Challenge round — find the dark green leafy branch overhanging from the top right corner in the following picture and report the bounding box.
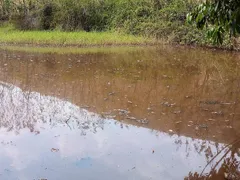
[187,0,240,44]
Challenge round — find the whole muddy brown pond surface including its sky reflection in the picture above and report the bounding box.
[0,47,240,180]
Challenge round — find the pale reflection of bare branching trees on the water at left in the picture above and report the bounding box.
[0,82,104,135]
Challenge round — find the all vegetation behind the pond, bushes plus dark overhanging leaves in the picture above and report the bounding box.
[0,0,240,47]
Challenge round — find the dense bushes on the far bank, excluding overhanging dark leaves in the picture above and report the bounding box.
[0,0,205,44]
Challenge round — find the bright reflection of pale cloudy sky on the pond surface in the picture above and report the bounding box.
[0,84,234,180]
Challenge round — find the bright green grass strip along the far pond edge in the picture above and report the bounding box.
[0,27,155,46]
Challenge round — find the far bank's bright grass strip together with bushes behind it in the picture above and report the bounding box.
[0,0,206,45]
